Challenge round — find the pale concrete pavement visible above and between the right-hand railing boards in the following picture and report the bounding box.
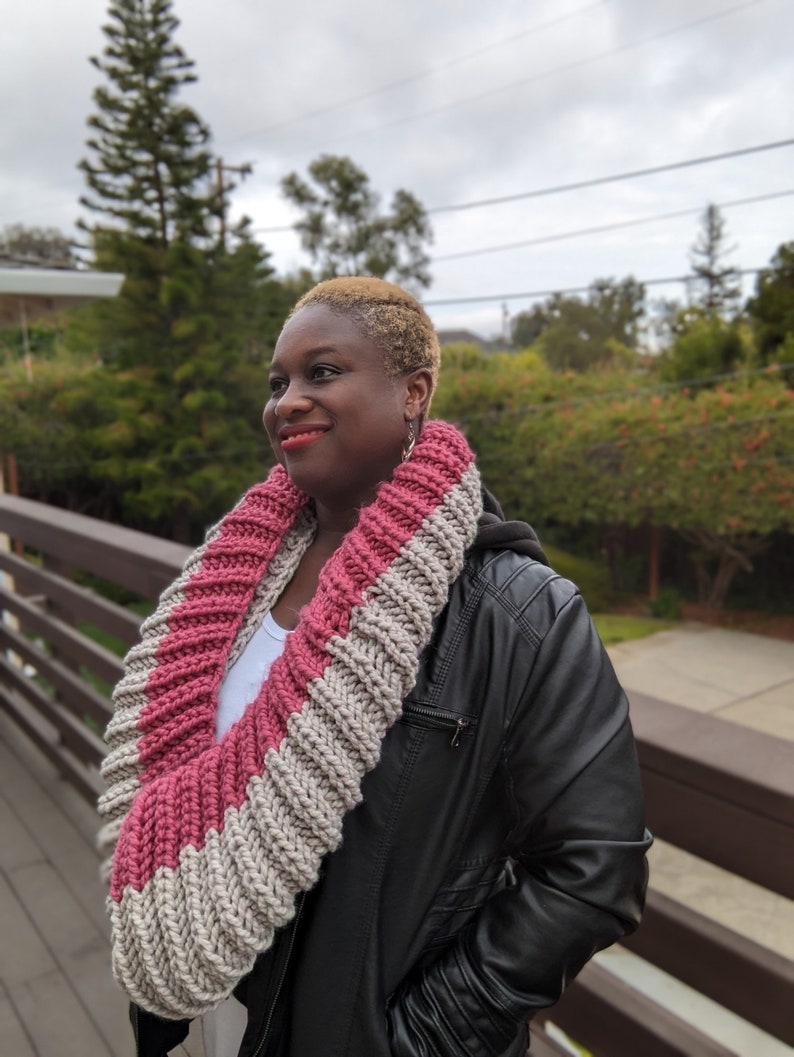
[597,624,794,1057]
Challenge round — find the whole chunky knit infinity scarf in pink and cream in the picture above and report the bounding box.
[99,423,481,1019]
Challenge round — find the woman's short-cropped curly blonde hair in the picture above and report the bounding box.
[287,276,441,386]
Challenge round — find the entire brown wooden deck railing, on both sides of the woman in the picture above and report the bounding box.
[0,496,794,1057]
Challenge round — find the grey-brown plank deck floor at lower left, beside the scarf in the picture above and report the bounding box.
[0,715,203,1057]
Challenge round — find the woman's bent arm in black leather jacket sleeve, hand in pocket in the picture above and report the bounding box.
[389,581,650,1057]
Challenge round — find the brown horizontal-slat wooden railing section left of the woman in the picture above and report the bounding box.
[0,495,188,802]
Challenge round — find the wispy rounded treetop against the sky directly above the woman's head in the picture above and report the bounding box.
[281,154,432,288]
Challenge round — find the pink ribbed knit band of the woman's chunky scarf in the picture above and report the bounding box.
[111,423,473,902]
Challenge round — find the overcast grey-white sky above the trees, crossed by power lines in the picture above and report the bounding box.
[0,0,794,336]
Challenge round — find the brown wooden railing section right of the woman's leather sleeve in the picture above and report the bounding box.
[551,693,794,1057]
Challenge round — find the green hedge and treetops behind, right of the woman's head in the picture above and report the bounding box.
[441,217,794,607]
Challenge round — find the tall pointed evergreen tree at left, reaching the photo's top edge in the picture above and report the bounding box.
[75,0,283,540]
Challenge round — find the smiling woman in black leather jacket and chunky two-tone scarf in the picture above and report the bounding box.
[100,278,649,1057]
